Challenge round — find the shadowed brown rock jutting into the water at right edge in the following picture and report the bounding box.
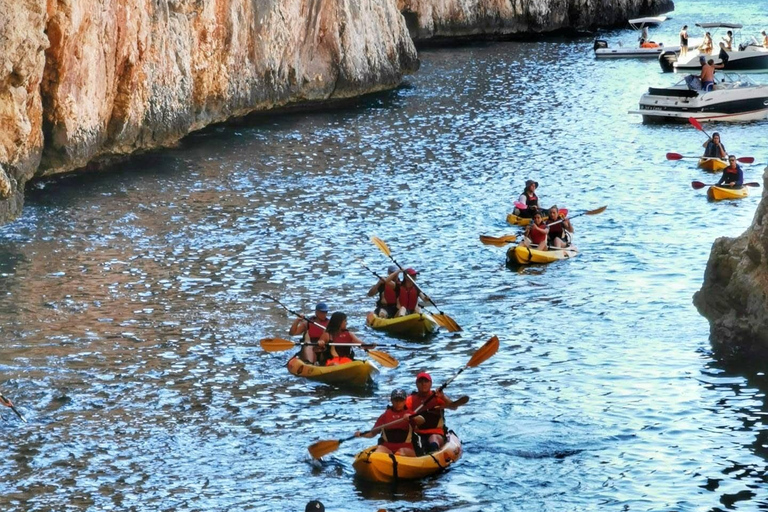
[693,167,768,359]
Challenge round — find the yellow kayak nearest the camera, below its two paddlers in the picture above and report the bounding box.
[352,432,462,483]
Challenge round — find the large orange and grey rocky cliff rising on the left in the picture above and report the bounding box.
[0,0,418,221]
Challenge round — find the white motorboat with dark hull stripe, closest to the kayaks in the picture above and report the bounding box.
[629,74,768,123]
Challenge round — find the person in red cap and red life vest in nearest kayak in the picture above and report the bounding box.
[405,372,453,455]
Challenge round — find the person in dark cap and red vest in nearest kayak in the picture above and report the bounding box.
[355,389,424,457]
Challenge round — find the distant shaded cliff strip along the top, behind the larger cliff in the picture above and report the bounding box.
[397,0,674,42]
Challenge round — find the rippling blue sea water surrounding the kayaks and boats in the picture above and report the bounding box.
[0,2,768,511]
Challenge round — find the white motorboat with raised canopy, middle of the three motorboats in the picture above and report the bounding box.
[659,23,768,73]
